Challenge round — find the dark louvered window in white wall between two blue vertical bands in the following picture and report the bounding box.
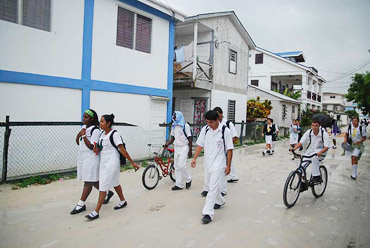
[116,7,152,53]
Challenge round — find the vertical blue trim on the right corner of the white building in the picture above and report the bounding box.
[166,19,175,139]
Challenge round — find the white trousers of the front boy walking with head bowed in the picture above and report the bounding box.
[202,169,225,219]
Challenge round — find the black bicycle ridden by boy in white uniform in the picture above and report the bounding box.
[283,151,328,208]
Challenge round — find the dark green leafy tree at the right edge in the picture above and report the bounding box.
[345,71,370,115]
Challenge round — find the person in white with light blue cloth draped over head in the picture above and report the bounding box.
[165,111,193,190]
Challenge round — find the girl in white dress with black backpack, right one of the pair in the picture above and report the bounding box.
[85,114,139,220]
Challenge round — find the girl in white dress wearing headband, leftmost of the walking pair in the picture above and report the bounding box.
[71,109,100,214]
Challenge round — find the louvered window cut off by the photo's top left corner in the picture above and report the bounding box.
[0,0,51,31]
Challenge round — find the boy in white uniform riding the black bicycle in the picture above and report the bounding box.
[292,118,330,182]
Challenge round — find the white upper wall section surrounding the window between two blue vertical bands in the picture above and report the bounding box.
[91,0,169,89]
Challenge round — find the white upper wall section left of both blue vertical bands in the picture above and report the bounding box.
[0,0,84,79]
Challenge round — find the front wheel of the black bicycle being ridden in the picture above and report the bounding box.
[283,171,301,208]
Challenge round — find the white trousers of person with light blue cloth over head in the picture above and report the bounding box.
[174,146,191,188]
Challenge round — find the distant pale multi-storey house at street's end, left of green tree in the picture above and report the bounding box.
[323,92,348,125]
